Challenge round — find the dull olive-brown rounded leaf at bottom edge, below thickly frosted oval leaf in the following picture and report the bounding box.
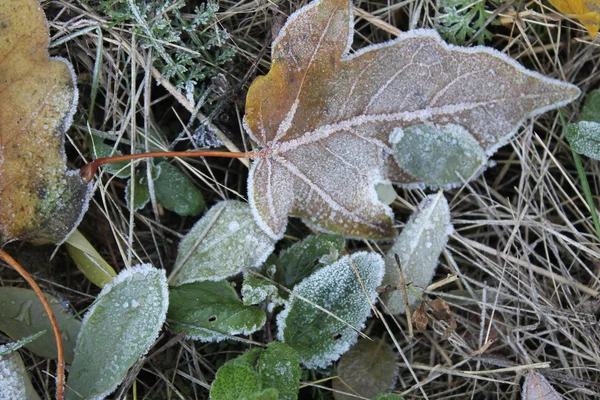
[333,339,398,400]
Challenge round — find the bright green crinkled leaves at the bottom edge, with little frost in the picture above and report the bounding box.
[210,342,301,400]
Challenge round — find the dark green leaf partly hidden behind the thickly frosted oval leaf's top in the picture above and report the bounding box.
[277,234,345,289]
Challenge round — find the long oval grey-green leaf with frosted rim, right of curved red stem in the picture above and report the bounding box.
[66,264,169,400]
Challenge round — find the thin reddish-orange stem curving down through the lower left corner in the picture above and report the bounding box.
[0,249,65,400]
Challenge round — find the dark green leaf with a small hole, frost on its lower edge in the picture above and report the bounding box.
[168,281,266,342]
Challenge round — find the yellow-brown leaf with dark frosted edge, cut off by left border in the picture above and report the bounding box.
[0,0,90,245]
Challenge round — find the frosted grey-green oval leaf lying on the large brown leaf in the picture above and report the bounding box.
[390,124,487,186]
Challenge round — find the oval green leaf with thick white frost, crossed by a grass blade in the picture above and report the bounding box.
[277,252,385,369]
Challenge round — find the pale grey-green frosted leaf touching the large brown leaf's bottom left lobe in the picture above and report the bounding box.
[169,201,274,286]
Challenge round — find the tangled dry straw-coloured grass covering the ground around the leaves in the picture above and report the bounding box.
[2,0,600,400]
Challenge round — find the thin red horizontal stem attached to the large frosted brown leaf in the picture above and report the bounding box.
[79,150,266,182]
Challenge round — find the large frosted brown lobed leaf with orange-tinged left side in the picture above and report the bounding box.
[245,0,579,239]
